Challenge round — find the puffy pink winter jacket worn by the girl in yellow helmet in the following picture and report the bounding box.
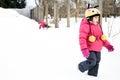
[79,18,110,52]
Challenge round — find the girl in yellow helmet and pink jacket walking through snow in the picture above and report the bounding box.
[78,8,114,76]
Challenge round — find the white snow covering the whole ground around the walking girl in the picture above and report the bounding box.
[0,8,120,80]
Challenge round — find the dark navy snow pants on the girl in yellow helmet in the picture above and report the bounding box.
[78,51,101,76]
